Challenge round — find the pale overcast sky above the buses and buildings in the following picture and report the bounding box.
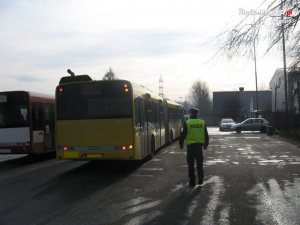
[0,0,288,100]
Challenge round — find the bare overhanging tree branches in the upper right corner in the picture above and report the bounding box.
[215,0,300,65]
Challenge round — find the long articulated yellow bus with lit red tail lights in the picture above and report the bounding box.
[56,75,183,160]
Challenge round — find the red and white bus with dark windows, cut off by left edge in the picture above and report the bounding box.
[0,91,55,154]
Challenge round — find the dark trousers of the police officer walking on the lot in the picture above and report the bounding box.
[186,144,204,183]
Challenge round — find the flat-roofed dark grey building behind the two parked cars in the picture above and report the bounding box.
[213,88,272,125]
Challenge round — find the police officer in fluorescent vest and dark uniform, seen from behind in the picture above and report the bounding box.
[179,108,209,187]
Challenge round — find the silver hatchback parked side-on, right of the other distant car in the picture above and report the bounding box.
[231,118,269,133]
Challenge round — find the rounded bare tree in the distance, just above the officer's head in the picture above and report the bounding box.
[190,80,212,116]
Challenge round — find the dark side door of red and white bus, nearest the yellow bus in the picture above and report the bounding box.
[43,104,54,151]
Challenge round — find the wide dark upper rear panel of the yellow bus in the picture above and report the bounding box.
[56,81,132,120]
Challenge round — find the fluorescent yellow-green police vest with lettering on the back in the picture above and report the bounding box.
[184,119,205,145]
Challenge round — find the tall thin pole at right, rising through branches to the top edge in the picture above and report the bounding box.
[280,0,289,131]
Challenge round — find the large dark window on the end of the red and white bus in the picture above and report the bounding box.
[0,92,29,128]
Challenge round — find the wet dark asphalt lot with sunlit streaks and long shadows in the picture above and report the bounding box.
[0,128,300,225]
